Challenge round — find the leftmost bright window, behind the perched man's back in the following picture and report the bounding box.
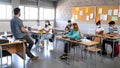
[0,4,12,20]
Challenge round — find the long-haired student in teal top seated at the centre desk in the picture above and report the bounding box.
[60,23,82,59]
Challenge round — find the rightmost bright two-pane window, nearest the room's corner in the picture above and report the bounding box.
[39,8,54,20]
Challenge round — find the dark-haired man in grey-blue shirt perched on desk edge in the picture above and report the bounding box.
[10,8,38,61]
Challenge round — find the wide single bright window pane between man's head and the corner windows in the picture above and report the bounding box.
[25,7,38,20]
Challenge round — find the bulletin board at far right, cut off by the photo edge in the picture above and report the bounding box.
[96,5,120,24]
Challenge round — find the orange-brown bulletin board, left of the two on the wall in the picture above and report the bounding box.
[71,6,96,22]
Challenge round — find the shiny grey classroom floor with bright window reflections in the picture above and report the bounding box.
[2,42,120,68]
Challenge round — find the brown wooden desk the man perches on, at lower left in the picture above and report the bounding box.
[0,41,26,68]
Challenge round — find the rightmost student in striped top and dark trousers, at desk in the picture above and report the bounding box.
[102,21,118,55]
